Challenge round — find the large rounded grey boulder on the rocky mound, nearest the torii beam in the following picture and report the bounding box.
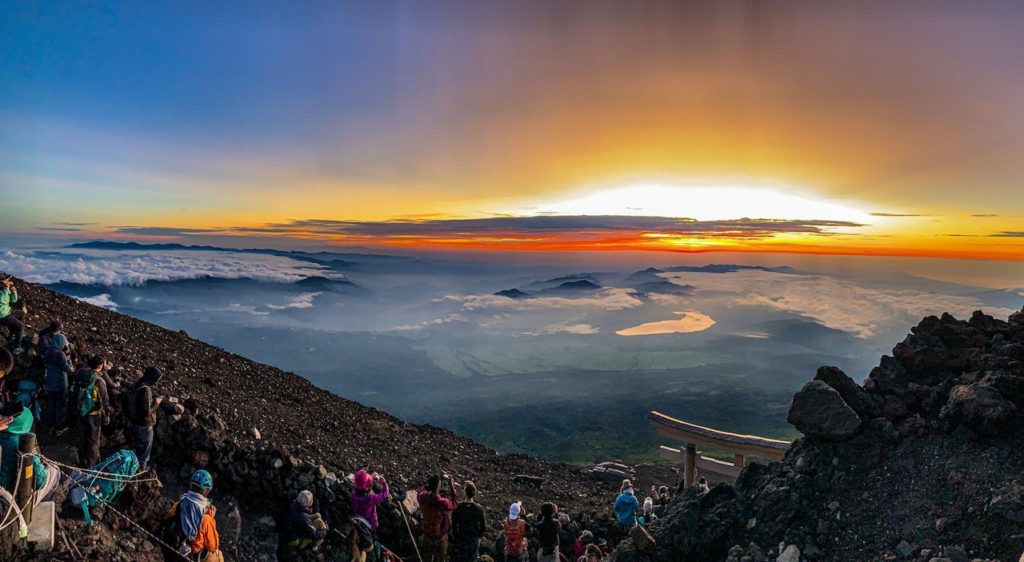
[786,380,860,441]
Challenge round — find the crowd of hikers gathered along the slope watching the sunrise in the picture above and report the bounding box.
[0,278,708,562]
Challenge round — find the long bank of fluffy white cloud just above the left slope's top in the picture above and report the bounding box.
[0,250,327,286]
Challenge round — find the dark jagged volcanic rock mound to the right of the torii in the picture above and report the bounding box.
[615,311,1024,562]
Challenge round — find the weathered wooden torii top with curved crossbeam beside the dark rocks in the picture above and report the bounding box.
[647,412,791,486]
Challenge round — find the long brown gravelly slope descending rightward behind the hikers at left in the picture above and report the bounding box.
[4,282,615,560]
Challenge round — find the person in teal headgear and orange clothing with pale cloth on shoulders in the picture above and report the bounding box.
[165,470,224,562]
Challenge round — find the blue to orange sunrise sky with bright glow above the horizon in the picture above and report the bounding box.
[0,0,1024,261]
